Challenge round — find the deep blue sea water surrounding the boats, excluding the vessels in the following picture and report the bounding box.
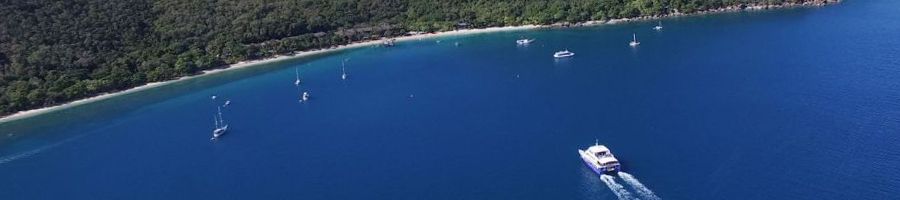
[0,0,900,199]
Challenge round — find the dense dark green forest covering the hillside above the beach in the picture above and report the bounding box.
[0,0,822,115]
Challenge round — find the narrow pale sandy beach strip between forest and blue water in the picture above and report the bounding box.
[0,0,841,123]
